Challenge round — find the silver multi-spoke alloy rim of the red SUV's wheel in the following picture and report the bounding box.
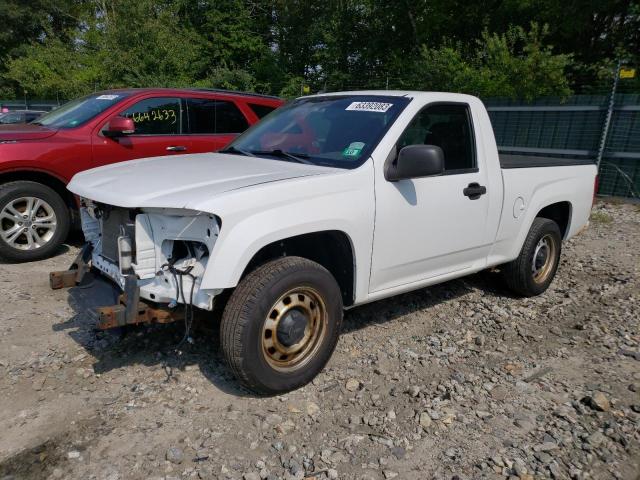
[0,197,57,251]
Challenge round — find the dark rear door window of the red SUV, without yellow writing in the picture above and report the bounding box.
[187,98,249,134]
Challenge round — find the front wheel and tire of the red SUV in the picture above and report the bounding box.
[0,181,70,262]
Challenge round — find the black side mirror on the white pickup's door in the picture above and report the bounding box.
[384,145,444,182]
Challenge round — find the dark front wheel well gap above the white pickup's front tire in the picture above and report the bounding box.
[242,230,355,306]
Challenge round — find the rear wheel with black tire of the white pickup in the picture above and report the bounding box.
[502,217,562,297]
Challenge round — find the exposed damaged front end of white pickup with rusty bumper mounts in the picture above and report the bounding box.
[50,199,221,328]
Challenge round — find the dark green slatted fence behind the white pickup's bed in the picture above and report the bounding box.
[485,94,640,198]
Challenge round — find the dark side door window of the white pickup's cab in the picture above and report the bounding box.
[398,105,476,170]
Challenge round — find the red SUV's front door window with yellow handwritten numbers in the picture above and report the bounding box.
[121,97,181,135]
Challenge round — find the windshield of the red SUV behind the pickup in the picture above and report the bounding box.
[32,93,127,128]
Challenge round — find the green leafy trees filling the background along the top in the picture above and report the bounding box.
[0,0,640,98]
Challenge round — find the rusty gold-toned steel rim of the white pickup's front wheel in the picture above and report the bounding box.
[261,287,328,372]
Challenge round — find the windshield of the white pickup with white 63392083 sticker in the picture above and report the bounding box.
[223,95,410,168]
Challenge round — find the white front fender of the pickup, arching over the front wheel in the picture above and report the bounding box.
[202,162,374,298]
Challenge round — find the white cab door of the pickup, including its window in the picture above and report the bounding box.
[370,103,491,293]
